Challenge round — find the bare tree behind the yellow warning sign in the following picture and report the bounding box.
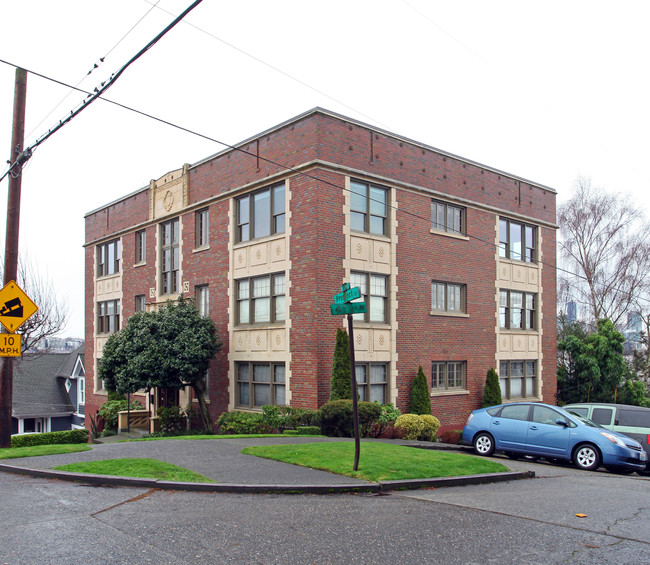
[2,257,69,355]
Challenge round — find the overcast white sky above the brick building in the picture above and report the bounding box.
[0,0,650,337]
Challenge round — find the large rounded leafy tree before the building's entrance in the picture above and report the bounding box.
[98,297,221,432]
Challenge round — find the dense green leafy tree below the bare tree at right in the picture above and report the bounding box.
[557,319,629,403]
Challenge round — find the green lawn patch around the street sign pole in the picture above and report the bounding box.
[242,442,509,482]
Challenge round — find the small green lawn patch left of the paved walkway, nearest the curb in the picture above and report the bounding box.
[54,458,215,483]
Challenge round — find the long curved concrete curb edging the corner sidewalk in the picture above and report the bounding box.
[0,464,535,494]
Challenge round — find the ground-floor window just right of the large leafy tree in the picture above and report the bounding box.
[237,363,286,408]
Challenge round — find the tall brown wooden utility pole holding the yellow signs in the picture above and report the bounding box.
[0,68,29,447]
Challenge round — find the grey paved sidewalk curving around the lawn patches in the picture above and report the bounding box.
[0,434,534,494]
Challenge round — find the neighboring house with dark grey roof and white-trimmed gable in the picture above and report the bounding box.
[11,346,85,434]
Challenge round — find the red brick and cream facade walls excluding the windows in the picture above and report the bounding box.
[85,109,556,429]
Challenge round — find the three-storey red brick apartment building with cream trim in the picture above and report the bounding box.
[85,108,556,429]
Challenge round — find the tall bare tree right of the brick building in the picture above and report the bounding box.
[558,178,650,326]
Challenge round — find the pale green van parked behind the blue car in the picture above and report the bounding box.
[563,402,650,475]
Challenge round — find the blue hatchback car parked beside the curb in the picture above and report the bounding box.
[463,402,648,473]
